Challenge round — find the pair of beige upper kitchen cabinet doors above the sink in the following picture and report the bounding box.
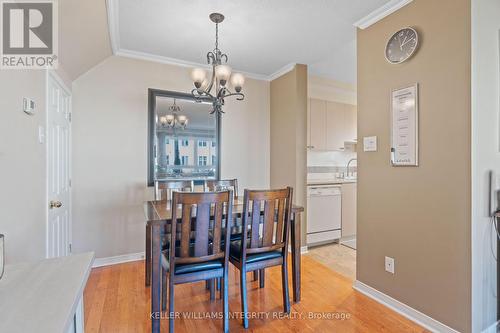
[307,98,357,151]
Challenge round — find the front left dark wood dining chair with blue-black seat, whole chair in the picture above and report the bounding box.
[162,191,233,332]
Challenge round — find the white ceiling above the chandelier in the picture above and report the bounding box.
[110,0,388,83]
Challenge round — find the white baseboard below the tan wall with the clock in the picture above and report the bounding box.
[352,280,459,333]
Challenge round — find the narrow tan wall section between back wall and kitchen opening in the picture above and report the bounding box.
[271,65,307,244]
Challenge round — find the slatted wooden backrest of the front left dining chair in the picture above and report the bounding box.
[170,191,233,266]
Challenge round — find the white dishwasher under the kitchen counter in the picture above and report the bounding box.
[307,185,342,245]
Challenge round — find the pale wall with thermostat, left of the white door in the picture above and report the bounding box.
[0,70,47,263]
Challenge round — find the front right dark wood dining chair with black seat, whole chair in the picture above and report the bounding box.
[229,187,293,328]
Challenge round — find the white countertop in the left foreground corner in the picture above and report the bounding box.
[0,253,94,333]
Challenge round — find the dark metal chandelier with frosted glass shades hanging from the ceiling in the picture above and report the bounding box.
[191,13,245,114]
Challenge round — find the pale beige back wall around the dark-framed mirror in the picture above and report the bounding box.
[73,56,270,258]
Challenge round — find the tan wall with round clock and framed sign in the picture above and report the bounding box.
[357,0,471,332]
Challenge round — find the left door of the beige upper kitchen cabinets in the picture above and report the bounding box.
[308,98,327,150]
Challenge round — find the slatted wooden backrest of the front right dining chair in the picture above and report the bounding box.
[241,187,293,260]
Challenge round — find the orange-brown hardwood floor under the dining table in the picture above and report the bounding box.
[84,256,426,332]
